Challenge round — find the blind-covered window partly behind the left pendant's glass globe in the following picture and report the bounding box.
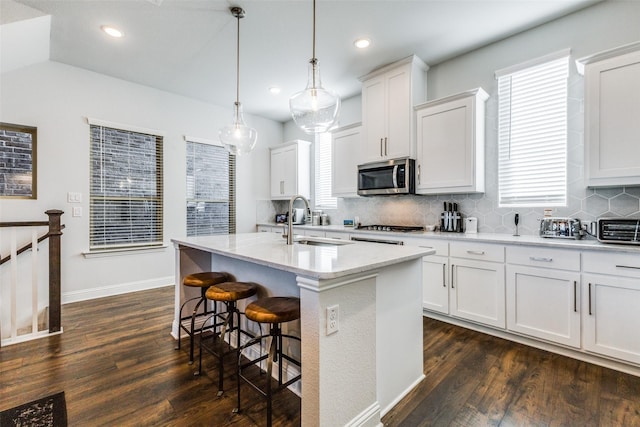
[186,137,236,236]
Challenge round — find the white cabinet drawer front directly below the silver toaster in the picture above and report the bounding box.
[507,246,580,271]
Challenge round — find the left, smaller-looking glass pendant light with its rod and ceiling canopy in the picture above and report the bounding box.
[218,7,258,155]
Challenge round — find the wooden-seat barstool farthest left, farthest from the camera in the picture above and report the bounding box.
[176,271,230,364]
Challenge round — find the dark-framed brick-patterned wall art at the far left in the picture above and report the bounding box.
[0,122,37,199]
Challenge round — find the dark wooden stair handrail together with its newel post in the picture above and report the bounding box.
[0,209,64,346]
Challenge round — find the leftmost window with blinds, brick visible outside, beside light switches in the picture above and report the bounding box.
[89,119,163,250]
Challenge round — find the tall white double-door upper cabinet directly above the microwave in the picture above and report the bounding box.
[360,55,429,163]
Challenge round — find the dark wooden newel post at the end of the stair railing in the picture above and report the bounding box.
[45,209,64,333]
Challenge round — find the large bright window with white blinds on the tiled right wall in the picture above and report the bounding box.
[496,51,569,207]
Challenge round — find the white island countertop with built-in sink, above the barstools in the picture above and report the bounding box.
[171,233,435,279]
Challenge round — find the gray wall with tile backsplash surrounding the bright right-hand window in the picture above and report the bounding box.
[282,1,640,234]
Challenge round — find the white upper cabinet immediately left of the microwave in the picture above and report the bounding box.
[331,123,362,197]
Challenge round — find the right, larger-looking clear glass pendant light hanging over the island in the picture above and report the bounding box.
[289,0,340,134]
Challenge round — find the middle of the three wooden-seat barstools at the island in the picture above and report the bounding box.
[196,282,258,396]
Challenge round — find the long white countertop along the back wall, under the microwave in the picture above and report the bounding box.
[257,223,640,255]
